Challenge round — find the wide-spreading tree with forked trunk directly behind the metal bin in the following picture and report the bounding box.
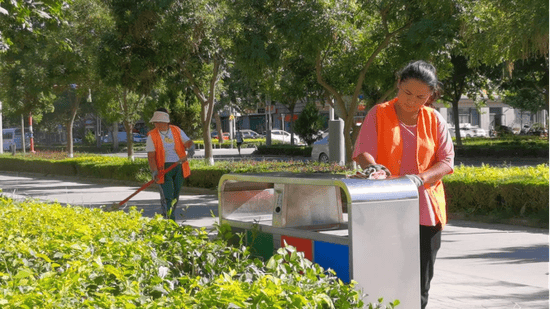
[236,0,457,162]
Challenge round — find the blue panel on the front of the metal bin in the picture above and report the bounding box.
[313,241,350,283]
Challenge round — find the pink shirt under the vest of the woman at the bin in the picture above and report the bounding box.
[352,105,455,226]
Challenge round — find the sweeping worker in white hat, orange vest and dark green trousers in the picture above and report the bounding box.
[145,108,193,220]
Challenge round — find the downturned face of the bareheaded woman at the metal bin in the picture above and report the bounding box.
[397,78,432,112]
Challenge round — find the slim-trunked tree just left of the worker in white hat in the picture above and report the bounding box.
[98,0,172,160]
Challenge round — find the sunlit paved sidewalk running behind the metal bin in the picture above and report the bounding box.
[0,172,550,309]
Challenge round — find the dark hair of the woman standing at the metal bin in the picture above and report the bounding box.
[397,60,441,102]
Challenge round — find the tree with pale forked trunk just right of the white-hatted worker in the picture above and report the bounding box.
[157,0,233,164]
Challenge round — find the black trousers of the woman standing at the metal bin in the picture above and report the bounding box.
[420,225,441,309]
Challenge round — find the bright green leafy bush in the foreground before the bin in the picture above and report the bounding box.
[0,197,380,309]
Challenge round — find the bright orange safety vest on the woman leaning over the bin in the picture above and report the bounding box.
[375,98,447,227]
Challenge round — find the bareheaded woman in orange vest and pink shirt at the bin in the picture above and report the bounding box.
[353,61,454,308]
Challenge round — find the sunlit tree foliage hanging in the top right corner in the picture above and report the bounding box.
[462,0,550,159]
